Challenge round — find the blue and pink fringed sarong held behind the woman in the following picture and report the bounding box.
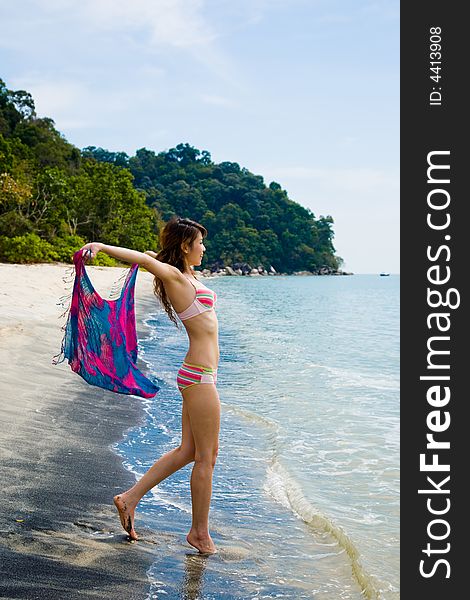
[53,250,160,398]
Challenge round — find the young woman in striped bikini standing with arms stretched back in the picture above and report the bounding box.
[82,217,220,554]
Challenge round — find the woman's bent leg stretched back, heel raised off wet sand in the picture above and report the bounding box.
[113,398,196,540]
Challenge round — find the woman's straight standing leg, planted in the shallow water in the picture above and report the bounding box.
[182,383,220,553]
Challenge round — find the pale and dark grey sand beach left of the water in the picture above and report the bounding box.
[0,263,165,599]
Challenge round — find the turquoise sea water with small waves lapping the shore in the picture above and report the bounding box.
[114,275,400,600]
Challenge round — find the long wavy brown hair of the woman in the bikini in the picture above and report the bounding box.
[153,216,207,327]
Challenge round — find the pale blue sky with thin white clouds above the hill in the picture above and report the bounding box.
[0,0,400,273]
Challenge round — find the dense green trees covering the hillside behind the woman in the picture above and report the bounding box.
[0,79,342,273]
